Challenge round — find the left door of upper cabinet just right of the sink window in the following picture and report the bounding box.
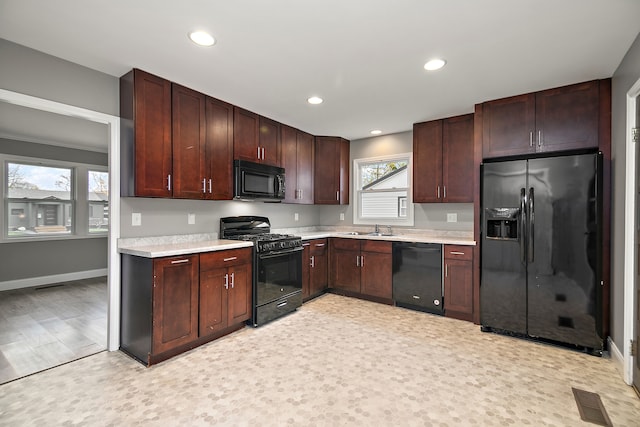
[413,120,442,203]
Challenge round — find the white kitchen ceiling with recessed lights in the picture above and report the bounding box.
[0,0,640,149]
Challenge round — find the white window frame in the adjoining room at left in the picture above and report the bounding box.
[0,153,111,243]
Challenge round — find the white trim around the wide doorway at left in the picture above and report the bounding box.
[0,89,120,351]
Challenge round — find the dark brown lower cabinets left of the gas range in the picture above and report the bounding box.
[120,248,252,365]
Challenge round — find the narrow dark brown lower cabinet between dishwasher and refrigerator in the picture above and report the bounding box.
[444,245,473,321]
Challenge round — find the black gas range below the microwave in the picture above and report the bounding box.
[220,216,303,326]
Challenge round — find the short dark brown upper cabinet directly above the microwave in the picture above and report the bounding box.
[233,107,280,166]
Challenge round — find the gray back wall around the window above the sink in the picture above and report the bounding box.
[319,131,473,231]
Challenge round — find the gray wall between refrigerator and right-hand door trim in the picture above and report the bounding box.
[611,34,640,350]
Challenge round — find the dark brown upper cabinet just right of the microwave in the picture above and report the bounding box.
[280,125,314,204]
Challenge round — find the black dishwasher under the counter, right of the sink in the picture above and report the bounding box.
[393,242,444,315]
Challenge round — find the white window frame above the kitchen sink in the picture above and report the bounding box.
[352,153,414,227]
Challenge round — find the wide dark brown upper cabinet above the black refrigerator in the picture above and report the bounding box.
[482,80,600,158]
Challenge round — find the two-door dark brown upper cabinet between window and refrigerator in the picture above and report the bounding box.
[413,114,474,203]
